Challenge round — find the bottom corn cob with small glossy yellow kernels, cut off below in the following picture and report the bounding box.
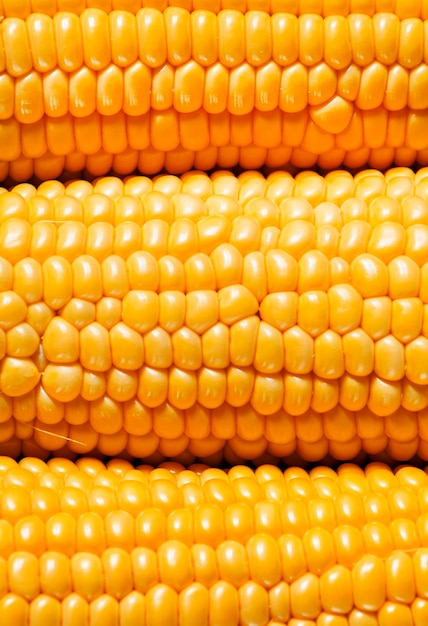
[0,457,428,626]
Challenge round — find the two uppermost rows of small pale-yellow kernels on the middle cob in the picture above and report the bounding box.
[5,167,428,210]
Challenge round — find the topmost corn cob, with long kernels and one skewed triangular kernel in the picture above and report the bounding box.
[0,7,428,181]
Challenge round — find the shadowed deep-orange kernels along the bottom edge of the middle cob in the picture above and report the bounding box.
[0,398,428,465]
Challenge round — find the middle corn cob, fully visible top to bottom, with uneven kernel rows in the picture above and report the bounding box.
[0,168,428,463]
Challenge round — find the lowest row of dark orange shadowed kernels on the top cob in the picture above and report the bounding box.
[0,141,428,180]
